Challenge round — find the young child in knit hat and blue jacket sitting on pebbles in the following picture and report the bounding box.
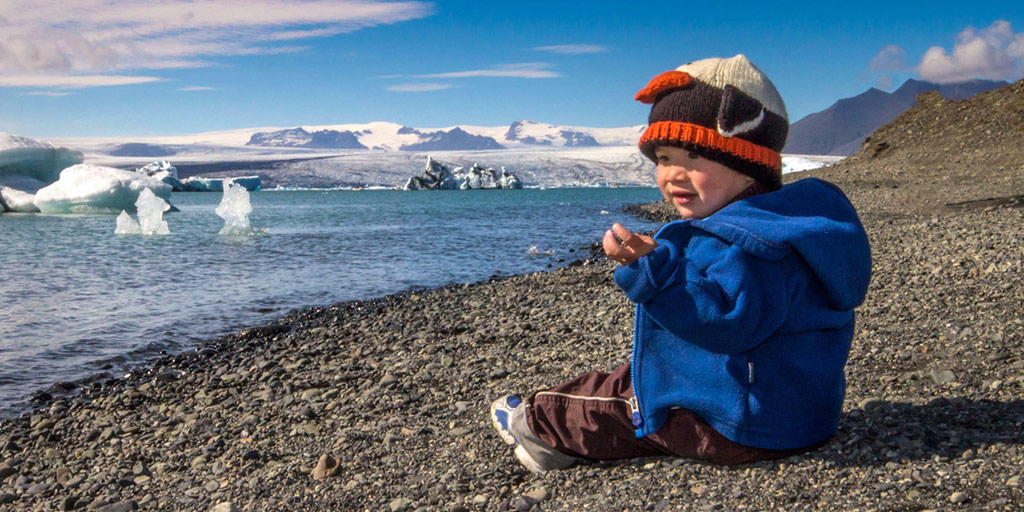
[490,55,871,472]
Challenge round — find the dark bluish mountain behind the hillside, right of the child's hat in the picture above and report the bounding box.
[782,80,1008,157]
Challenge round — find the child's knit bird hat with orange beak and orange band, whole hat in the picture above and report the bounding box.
[636,55,790,190]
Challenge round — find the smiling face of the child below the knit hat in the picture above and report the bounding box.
[654,145,754,219]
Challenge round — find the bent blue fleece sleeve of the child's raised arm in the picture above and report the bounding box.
[615,237,800,353]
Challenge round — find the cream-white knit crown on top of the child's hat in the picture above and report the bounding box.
[676,54,790,121]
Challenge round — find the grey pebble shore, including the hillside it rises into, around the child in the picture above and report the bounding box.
[0,81,1024,512]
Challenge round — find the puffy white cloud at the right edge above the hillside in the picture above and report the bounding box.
[918,19,1024,83]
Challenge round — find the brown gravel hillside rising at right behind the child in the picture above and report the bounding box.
[787,80,1024,213]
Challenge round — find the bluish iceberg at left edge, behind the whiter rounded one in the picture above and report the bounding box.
[0,132,82,183]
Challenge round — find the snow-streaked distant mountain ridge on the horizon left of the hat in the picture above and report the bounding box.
[245,121,643,152]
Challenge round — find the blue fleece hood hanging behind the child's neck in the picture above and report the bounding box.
[690,178,871,309]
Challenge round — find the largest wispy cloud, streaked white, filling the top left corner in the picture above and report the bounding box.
[0,0,433,86]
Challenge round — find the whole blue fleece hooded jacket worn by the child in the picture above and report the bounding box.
[615,178,871,450]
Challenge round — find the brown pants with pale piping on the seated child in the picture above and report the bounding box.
[526,364,811,465]
